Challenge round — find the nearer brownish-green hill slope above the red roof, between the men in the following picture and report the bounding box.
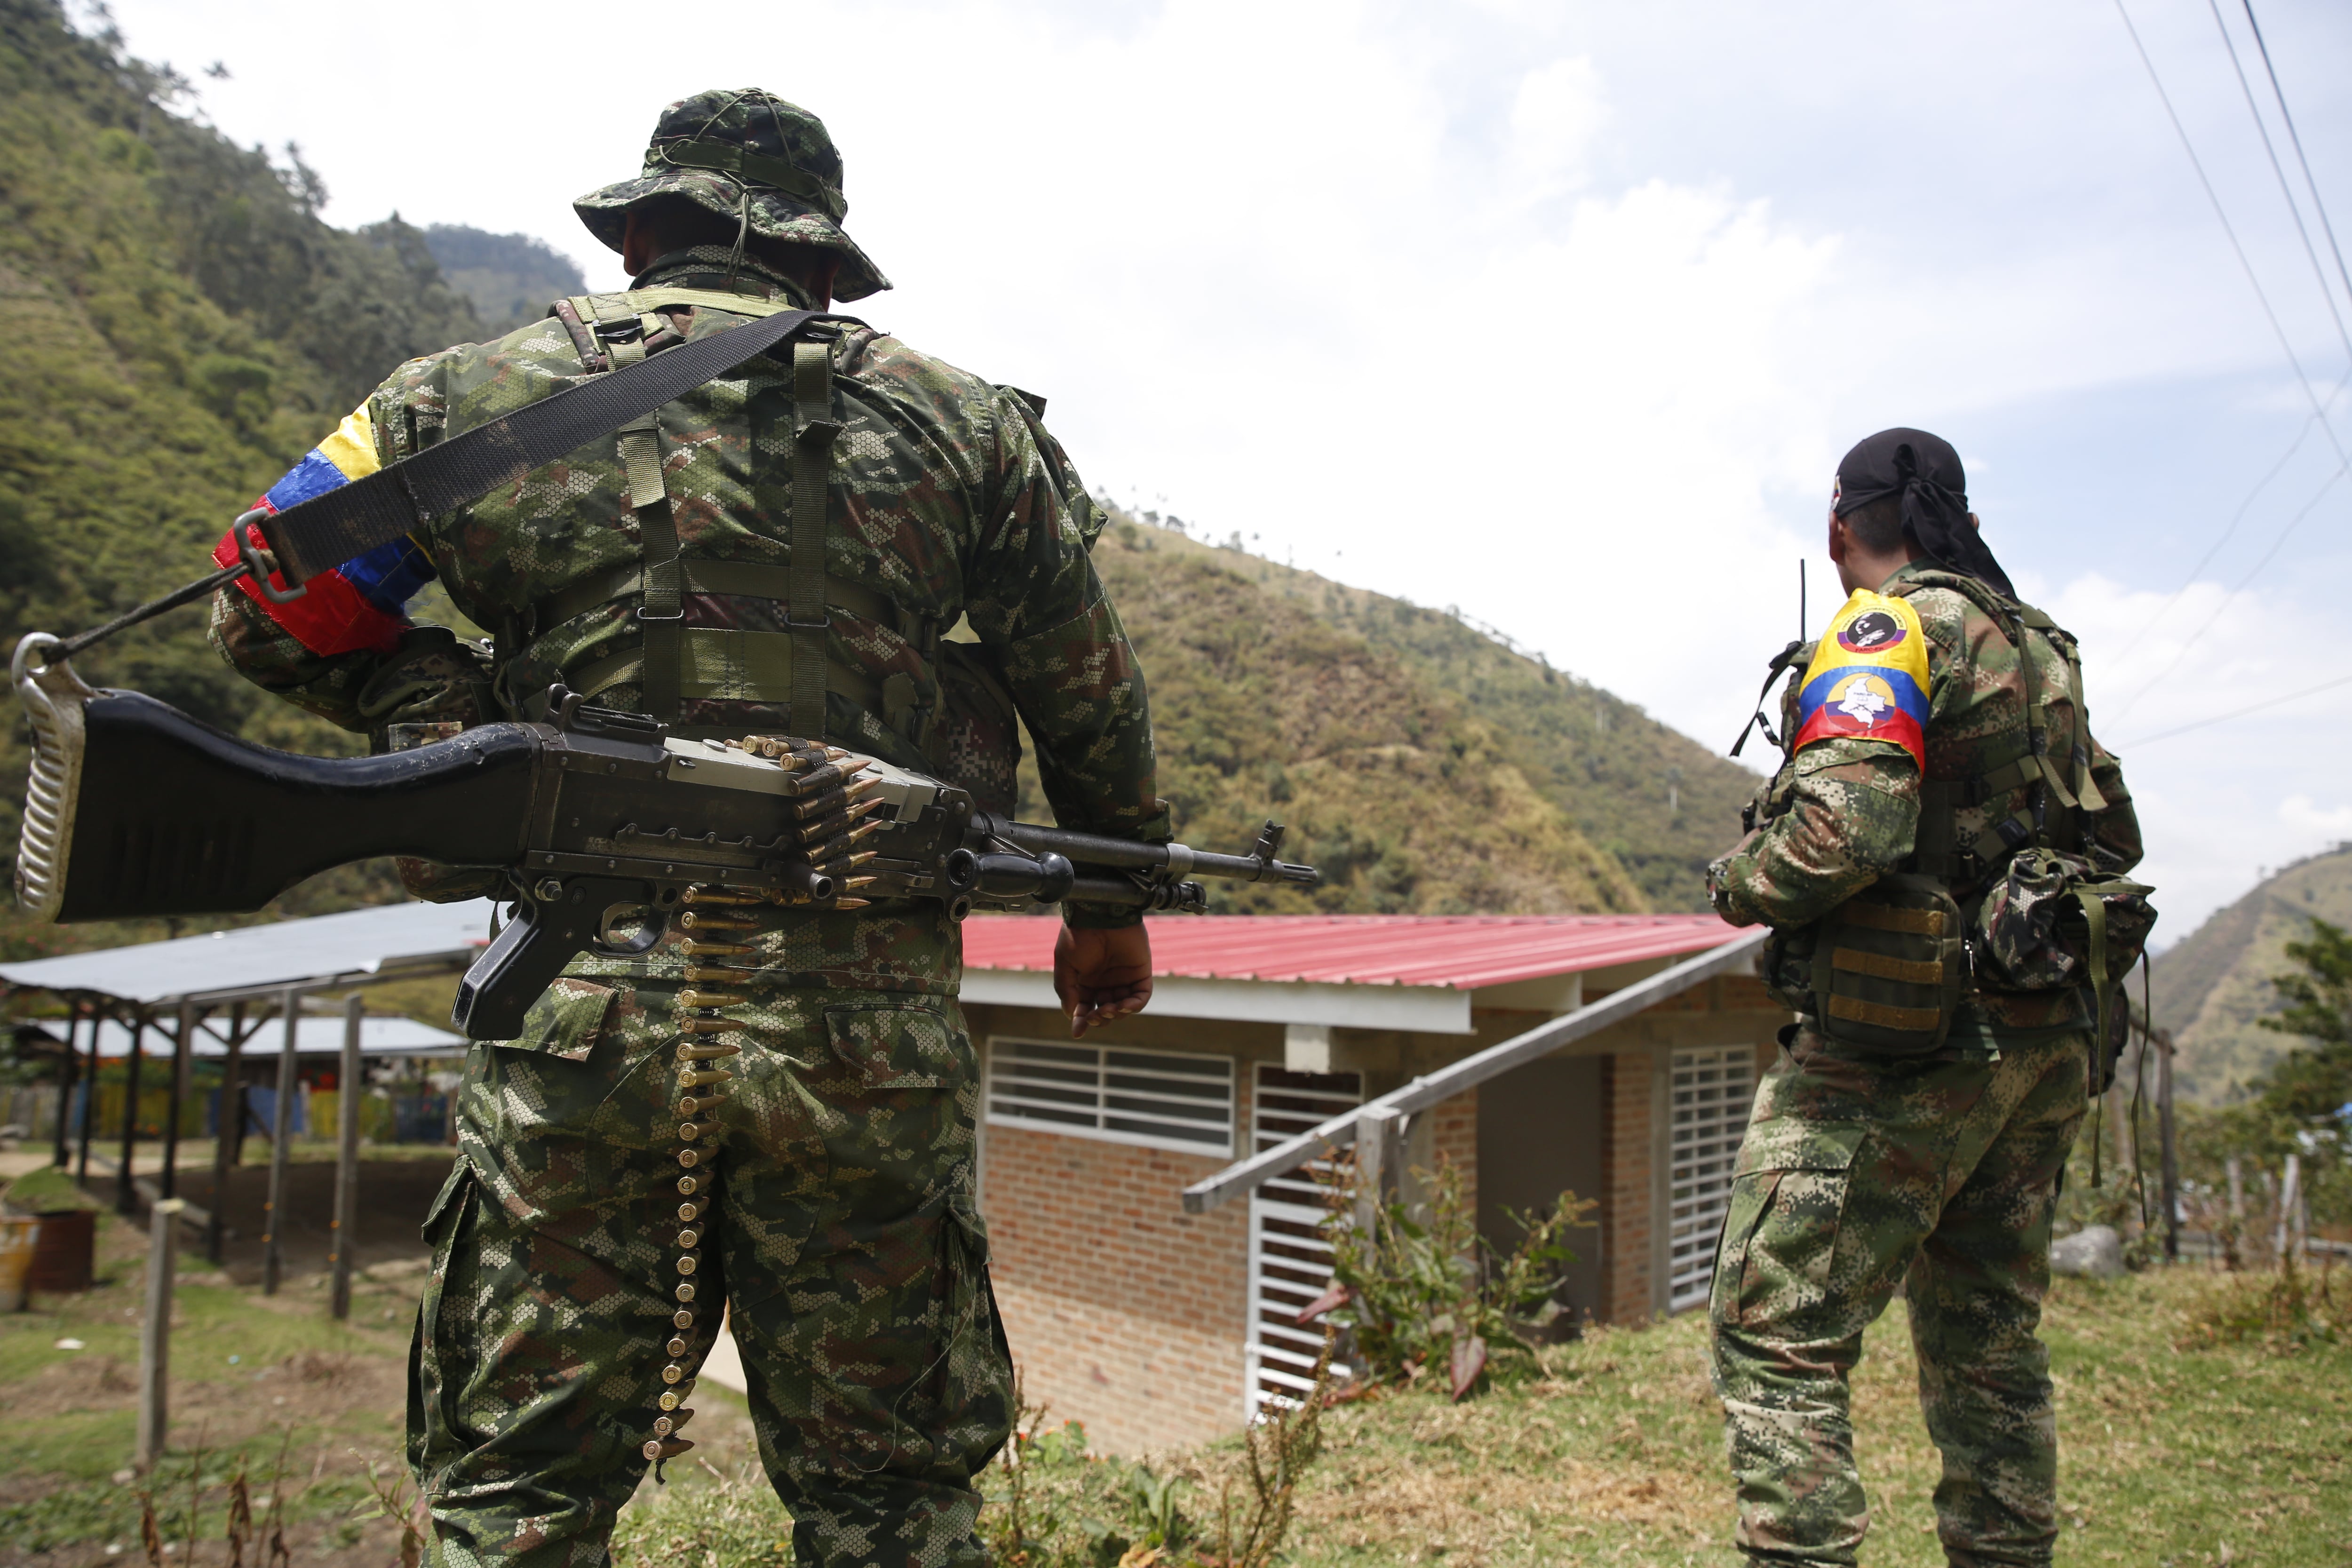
[1028,519,1649,915]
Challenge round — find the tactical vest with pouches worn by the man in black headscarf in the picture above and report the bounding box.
[1750,571,2154,1056]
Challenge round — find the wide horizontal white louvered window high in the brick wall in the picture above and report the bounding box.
[988,1035,1232,1159]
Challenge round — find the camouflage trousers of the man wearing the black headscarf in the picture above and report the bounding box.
[1710,1032,2091,1568]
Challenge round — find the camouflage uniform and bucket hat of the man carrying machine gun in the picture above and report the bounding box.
[214,94,1164,1568]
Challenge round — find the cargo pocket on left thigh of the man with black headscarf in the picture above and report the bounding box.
[1712,1119,1867,1323]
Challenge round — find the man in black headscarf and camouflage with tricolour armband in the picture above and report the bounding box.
[1708,430,2154,1563]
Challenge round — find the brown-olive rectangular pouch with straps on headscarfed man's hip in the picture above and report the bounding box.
[1804,875,1969,1056]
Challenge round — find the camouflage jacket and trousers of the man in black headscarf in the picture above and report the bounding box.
[1710,562,2140,1563]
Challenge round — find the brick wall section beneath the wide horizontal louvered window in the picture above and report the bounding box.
[981,1123,1249,1453]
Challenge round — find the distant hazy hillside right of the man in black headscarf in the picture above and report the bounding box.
[2150,846,2352,1105]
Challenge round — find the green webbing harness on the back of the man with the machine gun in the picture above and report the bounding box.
[522,287,938,755]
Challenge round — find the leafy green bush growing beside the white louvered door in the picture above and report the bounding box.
[1298,1157,1597,1401]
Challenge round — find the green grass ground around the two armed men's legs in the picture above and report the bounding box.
[0,1215,2352,1568]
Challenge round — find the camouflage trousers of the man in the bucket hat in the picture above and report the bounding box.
[409,978,1011,1568]
